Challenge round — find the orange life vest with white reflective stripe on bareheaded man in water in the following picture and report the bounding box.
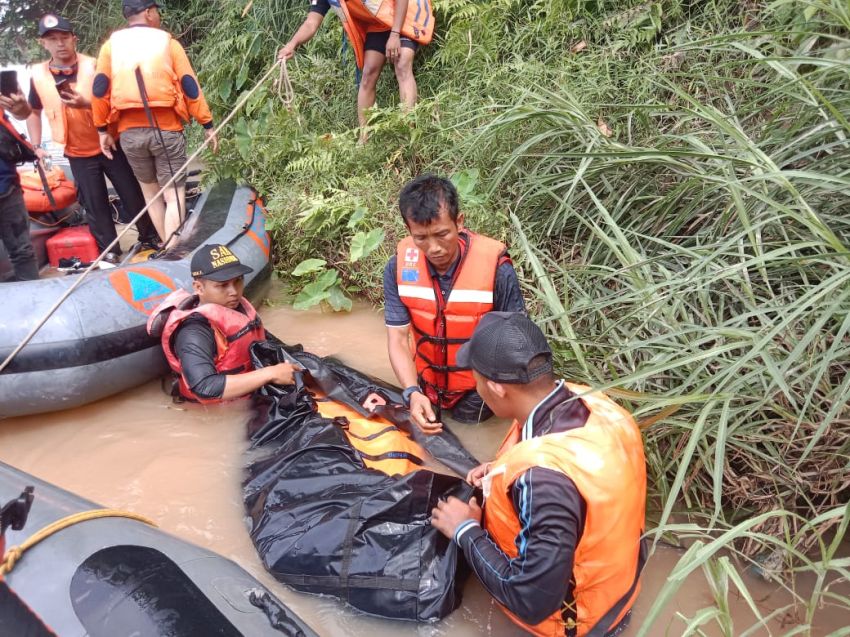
[396,231,507,408]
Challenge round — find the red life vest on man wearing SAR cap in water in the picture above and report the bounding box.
[147,289,266,403]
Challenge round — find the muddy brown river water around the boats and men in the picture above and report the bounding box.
[0,294,850,637]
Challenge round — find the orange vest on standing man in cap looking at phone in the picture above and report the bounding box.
[32,53,100,157]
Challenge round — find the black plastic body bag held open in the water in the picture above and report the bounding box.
[244,341,477,621]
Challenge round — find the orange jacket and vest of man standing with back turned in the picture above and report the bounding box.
[92,27,212,132]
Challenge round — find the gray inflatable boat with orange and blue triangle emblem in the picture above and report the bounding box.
[0,182,271,418]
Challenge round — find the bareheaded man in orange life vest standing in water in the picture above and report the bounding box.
[384,175,525,434]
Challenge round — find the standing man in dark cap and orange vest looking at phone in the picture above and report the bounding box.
[19,13,158,263]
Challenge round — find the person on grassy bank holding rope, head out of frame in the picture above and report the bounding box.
[278,0,435,127]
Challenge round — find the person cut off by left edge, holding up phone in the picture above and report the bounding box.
[0,79,38,281]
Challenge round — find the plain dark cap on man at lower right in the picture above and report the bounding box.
[456,312,552,384]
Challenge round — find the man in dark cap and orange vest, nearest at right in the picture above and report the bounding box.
[431,312,646,637]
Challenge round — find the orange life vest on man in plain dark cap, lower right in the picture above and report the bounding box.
[484,383,646,637]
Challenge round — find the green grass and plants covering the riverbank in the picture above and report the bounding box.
[29,0,850,635]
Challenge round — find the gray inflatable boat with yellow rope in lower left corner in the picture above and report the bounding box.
[0,463,316,637]
